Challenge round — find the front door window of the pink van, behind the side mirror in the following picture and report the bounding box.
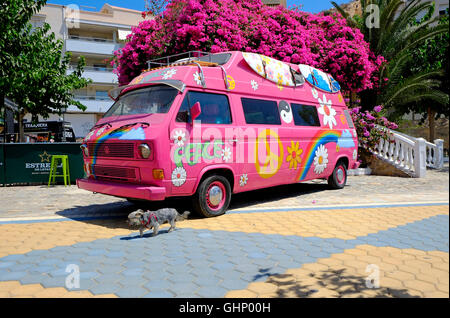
[176,91,231,124]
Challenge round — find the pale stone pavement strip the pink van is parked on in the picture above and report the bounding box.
[0,163,449,220]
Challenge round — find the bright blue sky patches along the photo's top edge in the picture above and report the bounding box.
[48,0,349,13]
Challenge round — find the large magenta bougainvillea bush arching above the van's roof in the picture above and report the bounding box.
[113,0,384,92]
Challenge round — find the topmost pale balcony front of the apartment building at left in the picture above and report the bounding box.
[65,35,123,56]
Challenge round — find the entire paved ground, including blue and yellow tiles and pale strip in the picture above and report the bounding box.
[0,165,449,298]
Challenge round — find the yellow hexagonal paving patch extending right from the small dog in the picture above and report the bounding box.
[177,206,449,239]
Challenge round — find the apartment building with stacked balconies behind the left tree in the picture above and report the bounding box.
[28,4,143,137]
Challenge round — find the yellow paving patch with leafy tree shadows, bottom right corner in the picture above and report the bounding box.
[225,245,449,298]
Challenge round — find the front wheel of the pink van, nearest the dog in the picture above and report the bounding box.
[193,175,231,218]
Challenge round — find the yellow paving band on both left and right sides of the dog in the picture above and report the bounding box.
[0,206,449,257]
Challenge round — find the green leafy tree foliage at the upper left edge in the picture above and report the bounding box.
[0,0,90,118]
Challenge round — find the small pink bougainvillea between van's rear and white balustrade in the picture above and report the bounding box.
[350,105,398,164]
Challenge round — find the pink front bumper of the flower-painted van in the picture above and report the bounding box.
[77,179,166,201]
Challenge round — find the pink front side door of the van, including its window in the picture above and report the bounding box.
[169,91,237,195]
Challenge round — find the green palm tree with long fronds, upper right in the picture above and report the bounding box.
[331,0,449,121]
